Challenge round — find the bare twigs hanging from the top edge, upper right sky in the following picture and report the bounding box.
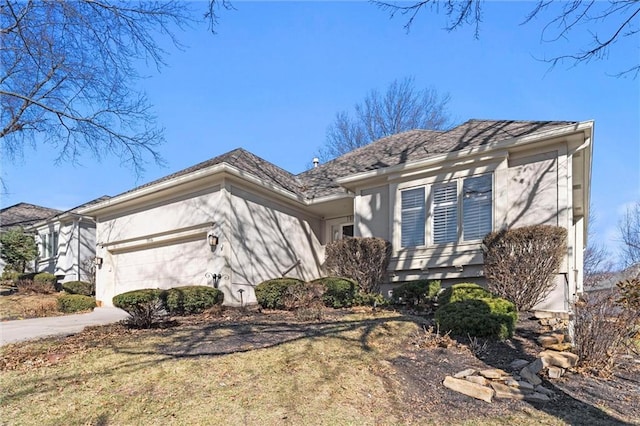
[373,0,640,78]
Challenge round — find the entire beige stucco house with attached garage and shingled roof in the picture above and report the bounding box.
[79,120,594,311]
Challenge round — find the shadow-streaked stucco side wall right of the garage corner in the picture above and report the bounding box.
[230,185,324,303]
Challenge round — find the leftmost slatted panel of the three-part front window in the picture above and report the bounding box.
[400,187,426,247]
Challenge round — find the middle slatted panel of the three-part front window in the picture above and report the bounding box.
[433,182,458,244]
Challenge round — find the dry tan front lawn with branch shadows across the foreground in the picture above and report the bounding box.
[0,309,639,425]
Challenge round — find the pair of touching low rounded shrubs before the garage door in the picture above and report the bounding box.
[113,286,224,328]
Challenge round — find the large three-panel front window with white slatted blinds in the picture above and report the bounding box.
[400,174,493,247]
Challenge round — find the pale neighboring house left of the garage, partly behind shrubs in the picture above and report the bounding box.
[27,196,109,282]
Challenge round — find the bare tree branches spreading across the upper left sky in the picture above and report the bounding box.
[0,0,198,172]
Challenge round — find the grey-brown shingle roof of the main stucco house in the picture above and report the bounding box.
[101,120,577,205]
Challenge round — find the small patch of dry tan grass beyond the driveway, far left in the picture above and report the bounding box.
[0,294,63,321]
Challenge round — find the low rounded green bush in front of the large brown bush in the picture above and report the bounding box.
[435,283,518,339]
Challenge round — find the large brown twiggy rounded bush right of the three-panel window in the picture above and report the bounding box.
[483,225,567,311]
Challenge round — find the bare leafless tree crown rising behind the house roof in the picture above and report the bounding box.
[319,77,451,161]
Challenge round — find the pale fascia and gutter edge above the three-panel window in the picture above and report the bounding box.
[336,120,594,186]
